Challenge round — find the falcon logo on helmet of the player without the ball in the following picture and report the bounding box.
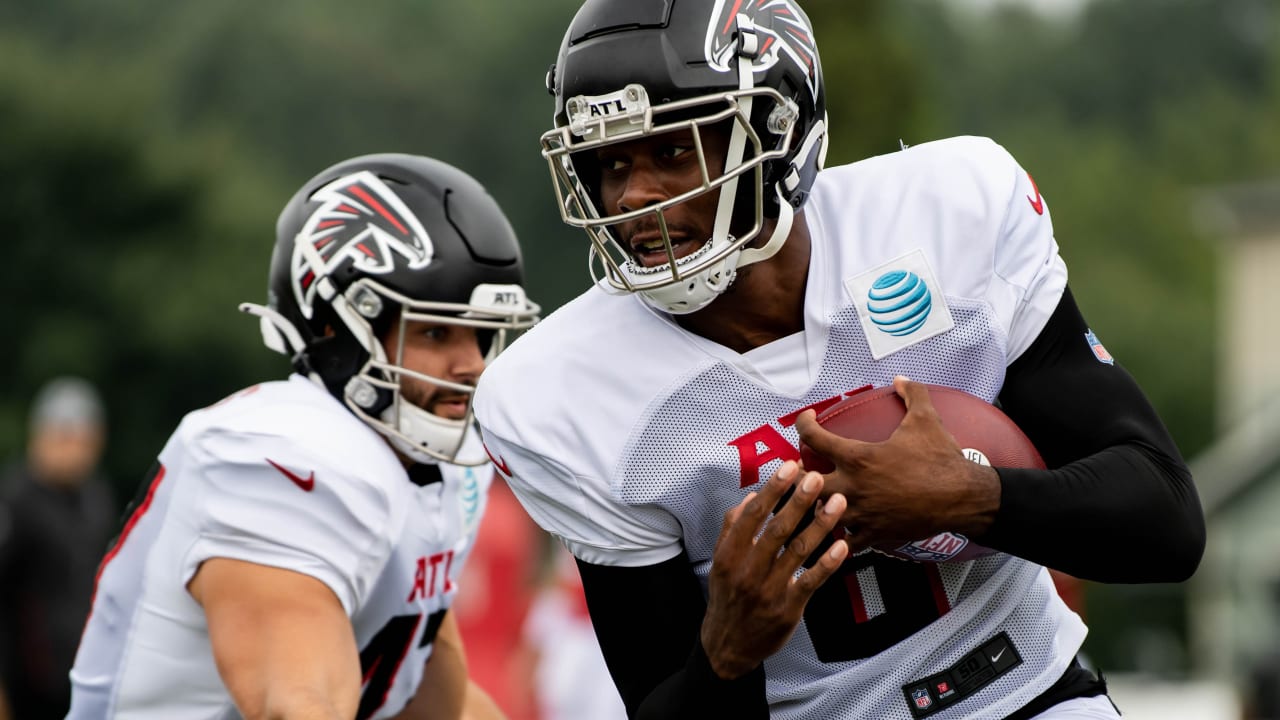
[292,170,434,318]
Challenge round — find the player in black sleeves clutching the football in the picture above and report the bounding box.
[476,0,1204,720]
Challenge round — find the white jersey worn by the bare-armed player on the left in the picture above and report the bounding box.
[68,375,493,720]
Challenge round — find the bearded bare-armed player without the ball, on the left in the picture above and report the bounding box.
[69,154,538,720]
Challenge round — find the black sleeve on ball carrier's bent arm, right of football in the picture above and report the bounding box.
[982,283,1204,583]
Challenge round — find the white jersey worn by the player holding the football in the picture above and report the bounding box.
[476,137,1085,720]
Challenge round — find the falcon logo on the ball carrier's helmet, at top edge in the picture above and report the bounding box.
[707,0,818,97]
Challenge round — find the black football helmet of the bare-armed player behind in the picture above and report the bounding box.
[241,154,539,465]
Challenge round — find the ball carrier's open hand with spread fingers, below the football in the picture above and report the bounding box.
[701,461,849,679]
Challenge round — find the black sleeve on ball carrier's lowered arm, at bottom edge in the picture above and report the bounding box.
[577,553,769,720]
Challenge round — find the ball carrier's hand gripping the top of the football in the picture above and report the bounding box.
[796,377,1000,550]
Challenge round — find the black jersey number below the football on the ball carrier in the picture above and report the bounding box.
[804,552,951,662]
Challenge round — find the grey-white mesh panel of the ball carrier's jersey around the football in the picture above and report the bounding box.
[612,297,1080,720]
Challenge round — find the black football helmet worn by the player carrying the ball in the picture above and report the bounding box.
[541,0,827,314]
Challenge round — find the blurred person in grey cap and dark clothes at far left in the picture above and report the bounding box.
[0,377,116,720]
